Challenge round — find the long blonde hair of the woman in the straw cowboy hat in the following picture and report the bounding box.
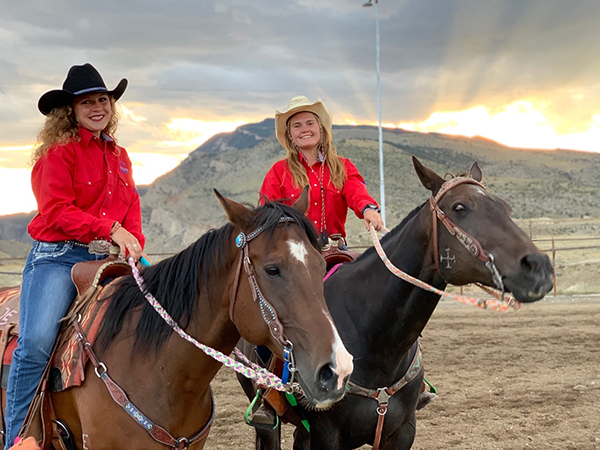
[285,111,346,189]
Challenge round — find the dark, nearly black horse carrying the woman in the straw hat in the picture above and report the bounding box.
[242,158,552,450]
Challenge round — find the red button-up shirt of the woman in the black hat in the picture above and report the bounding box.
[28,128,146,248]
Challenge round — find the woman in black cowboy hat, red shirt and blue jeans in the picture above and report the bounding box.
[5,64,145,448]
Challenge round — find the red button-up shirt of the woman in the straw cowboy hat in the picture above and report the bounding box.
[260,157,377,237]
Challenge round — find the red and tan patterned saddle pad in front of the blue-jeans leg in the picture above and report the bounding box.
[51,283,112,392]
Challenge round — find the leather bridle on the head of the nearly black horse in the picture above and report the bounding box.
[429,177,504,295]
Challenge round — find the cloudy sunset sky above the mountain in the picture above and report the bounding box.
[0,0,600,214]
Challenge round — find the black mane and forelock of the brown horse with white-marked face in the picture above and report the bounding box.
[97,202,319,352]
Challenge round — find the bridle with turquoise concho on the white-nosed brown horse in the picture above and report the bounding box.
[229,216,296,383]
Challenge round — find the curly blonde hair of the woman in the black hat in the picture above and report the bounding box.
[31,95,120,164]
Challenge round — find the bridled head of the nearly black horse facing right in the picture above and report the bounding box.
[413,156,553,302]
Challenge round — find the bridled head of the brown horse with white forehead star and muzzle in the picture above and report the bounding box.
[215,189,353,409]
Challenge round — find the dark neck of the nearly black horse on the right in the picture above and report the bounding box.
[326,207,445,383]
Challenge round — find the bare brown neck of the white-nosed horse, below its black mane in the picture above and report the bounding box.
[117,252,240,430]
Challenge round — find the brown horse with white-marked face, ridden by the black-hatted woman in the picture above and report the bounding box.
[4,192,352,450]
